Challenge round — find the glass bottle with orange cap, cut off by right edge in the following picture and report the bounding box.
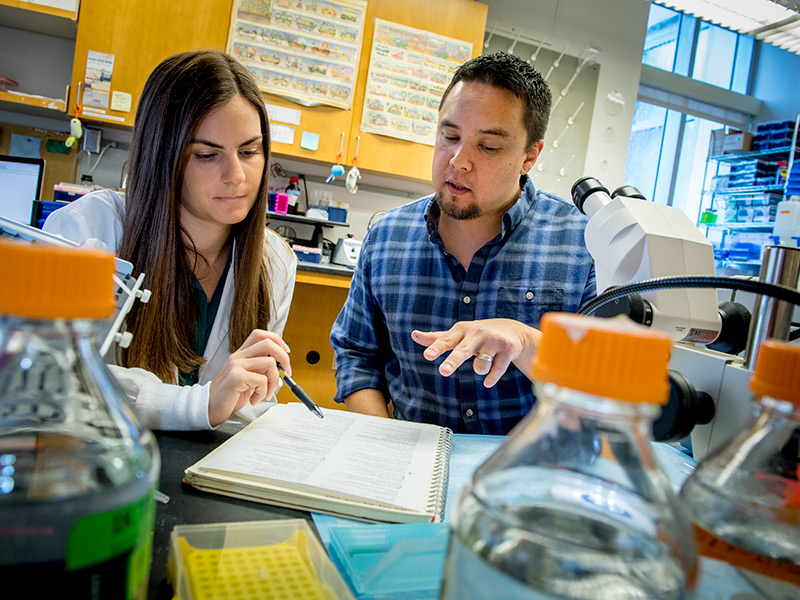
[680,340,800,598]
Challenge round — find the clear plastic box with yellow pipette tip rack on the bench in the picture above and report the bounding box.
[167,519,353,600]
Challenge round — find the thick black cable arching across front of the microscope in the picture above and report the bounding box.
[578,275,800,315]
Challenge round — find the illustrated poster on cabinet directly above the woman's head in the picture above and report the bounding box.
[228,0,367,109]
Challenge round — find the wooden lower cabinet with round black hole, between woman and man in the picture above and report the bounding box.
[278,271,350,409]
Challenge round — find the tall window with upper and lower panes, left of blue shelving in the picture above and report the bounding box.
[625,4,755,222]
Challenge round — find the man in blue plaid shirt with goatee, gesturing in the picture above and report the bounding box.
[331,53,595,434]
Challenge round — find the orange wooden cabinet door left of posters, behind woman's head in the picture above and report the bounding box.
[70,0,232,127]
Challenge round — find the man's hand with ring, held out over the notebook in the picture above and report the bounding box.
[411,319,542,387]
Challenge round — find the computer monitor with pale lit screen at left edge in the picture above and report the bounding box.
[0,154,44,225]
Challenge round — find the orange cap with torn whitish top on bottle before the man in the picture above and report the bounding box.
[533,313,672,404]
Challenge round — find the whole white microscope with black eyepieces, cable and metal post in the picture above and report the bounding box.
[572,177,800,460]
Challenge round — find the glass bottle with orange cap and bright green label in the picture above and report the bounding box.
[0,240,160,599]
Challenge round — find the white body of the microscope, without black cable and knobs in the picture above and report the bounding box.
[573,178,752,459]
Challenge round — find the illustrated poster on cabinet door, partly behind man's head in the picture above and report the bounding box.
[361,19,472,146]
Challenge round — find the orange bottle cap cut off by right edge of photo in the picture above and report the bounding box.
[750,340,800,406]
